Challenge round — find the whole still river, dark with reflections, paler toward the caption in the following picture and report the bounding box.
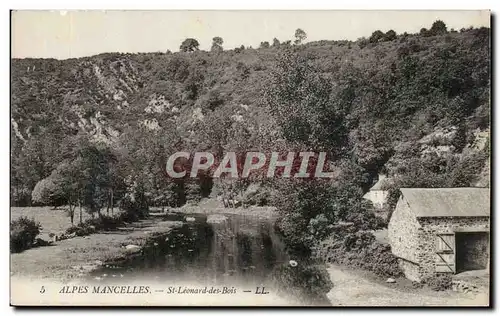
[92,213,332,305]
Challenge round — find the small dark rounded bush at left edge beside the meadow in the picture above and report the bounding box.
[10,217,41,252]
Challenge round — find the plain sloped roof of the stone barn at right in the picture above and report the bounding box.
[401,188,490,217]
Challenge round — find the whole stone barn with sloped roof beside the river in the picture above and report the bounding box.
[388,188,490,282]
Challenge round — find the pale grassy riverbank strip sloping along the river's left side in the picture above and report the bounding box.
[10,219,179,280]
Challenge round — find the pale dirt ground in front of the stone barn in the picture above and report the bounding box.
[328,265,488,306]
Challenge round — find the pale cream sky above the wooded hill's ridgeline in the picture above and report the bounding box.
[11,10,490,59]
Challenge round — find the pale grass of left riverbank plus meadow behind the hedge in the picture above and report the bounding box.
[10,207,178,280]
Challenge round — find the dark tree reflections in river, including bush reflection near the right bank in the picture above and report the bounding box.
[92,216,331,304]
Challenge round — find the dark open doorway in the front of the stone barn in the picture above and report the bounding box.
[456,232,489,273]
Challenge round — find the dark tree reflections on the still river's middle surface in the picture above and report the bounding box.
[95,214,288,283]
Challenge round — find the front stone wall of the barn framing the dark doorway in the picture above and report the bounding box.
[416,217,490,278]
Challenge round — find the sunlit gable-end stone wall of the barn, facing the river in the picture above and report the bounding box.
[387,196,420,264]
